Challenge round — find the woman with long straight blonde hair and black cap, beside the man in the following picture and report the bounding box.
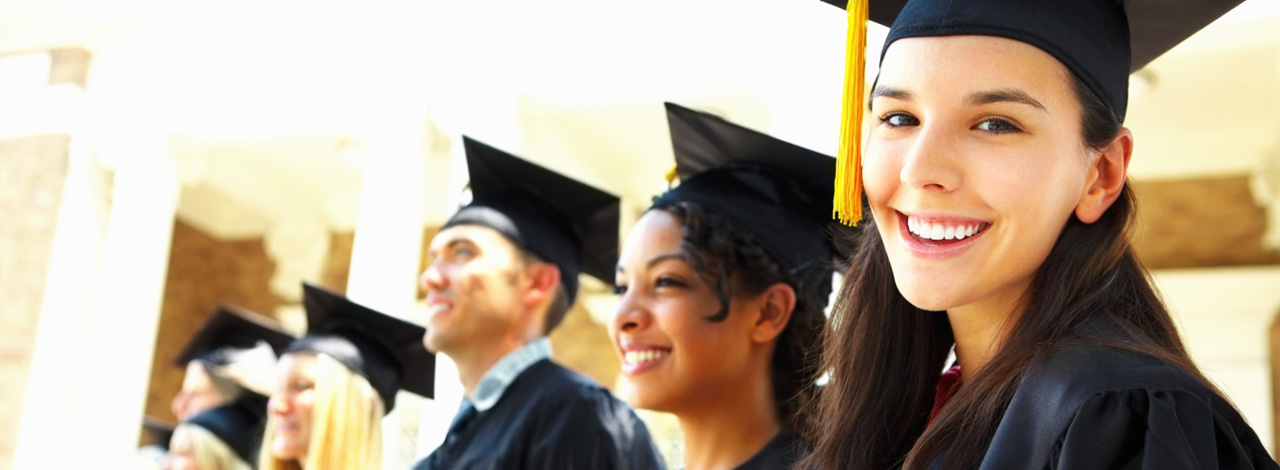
[259,284,435,470]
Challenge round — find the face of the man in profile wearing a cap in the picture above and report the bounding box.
[419,225,525,356]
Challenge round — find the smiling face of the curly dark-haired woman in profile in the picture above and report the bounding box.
[609,210,758,414]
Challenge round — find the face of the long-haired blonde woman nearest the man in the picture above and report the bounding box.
[268,353,317,460]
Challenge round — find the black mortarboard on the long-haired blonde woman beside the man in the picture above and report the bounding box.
[285,284,435,412]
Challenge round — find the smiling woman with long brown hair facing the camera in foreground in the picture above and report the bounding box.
[806,0,1276,469]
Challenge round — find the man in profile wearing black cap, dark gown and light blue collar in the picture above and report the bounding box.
[416,137,663,470]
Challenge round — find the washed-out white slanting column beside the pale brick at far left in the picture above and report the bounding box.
[15,129,179,469]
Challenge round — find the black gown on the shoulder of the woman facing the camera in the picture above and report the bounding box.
[967,344,1280,470]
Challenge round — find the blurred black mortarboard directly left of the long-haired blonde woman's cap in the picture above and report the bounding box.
[174,305,294,366]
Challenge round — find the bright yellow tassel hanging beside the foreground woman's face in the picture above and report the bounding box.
[833,0,869,227]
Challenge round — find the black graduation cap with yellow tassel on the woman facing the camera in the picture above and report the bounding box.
[823,0,1243,223]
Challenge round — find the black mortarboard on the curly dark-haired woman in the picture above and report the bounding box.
[654,102,837,277]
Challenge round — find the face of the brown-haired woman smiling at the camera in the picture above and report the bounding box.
[863,36,1092,312]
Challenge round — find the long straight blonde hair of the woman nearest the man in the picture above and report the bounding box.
[259,353,383,470]
